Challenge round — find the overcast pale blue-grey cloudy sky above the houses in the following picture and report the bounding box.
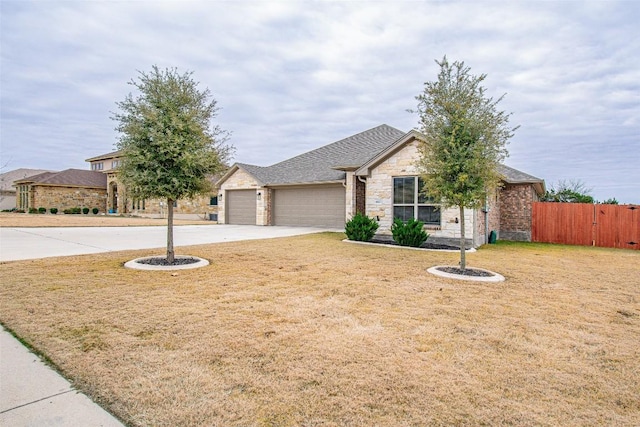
[0,0,640,203]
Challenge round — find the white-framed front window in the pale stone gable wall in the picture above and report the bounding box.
[393,176,440,226]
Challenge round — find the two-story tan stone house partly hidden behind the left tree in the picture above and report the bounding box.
[86,151,218,221]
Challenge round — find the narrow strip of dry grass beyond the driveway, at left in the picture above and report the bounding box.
[0,212,214,227]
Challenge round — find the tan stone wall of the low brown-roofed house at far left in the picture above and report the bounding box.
[29,185,107,213]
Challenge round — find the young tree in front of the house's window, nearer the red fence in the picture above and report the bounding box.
[416,56,517,270]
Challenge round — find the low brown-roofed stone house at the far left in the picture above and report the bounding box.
[14,169,107,212]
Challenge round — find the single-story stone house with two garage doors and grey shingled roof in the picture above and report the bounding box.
[217,125,544,246]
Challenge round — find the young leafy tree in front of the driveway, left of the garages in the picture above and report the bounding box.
[112,66,233,264]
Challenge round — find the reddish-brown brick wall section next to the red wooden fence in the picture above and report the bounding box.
[499,184,538,242]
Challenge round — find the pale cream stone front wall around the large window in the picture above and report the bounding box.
[366,141,478,245]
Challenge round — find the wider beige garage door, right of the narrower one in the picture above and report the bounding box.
[273,185,345,228]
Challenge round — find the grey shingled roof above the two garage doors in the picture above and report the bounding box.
[223,125,405,185]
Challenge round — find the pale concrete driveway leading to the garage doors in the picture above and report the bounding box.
[0,224,342,261]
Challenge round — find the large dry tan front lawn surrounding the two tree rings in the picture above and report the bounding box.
[0,233,640,427]
